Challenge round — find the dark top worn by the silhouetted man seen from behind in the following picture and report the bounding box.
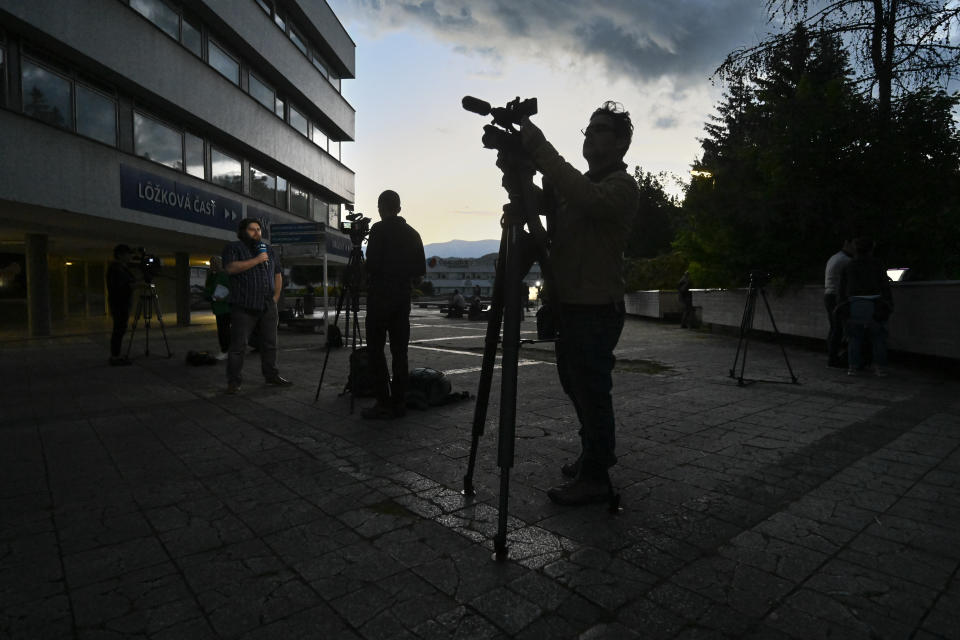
[366,216,427,302]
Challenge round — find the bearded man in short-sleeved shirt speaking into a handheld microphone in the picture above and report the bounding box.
[223,218,292,394]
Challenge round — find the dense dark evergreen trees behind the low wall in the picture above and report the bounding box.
[677,25,960,286]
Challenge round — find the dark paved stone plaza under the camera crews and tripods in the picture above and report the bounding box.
[0,311,960,640]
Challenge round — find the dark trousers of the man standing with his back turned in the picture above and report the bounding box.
[366,296,410,407]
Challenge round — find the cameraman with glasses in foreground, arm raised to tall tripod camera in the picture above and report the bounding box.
[520,102,640,505]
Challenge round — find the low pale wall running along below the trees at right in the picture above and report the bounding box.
[624,280,960,359]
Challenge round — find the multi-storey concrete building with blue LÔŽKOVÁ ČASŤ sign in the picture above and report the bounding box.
[0,0,355,335]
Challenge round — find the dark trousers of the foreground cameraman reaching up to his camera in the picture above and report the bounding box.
[556,303,625,474]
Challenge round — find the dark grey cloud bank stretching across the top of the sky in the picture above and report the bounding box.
[334,0,766,84]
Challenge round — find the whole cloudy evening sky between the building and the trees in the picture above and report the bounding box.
[328,0,767,243]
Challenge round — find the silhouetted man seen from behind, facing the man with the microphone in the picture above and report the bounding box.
[360,190,427,420]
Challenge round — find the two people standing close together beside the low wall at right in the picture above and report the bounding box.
[824,237,893,376]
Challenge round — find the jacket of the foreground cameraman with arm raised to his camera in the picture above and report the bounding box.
[532,140,640,305]
